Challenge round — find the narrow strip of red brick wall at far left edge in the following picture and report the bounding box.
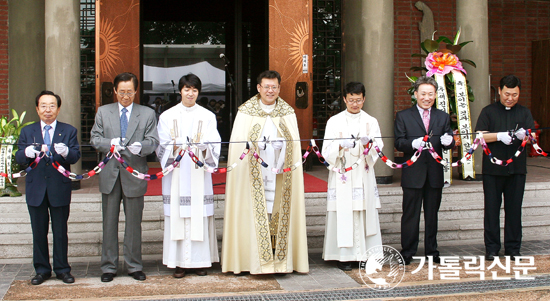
[0,0,9,116]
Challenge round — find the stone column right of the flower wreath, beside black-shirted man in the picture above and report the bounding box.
[456,0,491,179]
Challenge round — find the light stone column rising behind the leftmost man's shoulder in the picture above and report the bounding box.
[45,0,82,173]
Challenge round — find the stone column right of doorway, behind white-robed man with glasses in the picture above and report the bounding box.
[342,0,394,183]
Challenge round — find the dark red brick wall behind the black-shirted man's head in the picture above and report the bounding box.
[489,0,550,108]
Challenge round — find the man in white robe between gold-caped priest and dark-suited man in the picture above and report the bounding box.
[322,82,384,271]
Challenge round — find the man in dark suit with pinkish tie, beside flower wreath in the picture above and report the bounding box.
[395,76,454,265]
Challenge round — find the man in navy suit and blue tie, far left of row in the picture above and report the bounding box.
[15,91,80,285]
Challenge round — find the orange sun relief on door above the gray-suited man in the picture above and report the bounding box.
[99,19,123,74]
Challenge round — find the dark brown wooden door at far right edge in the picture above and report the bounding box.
[531,40,550,151]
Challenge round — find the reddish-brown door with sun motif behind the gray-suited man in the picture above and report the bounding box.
[96,0,141,111]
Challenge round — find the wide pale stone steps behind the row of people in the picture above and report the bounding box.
[0,183,550,259]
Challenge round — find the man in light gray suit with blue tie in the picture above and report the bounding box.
[91,73,159,282]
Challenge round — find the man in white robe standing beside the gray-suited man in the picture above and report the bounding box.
[157,74,221,278]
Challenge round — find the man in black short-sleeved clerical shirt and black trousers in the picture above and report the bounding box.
[476,75,535,261]
